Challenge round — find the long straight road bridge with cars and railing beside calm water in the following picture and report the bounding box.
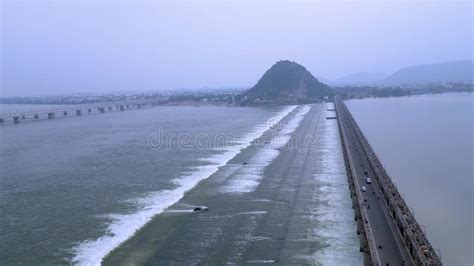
[334,97,442,265]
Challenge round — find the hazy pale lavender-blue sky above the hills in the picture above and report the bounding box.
[0,0,473,96]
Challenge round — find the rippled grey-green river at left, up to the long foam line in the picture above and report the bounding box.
[0,107,288,264]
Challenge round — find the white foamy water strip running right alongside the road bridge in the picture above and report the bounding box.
[309,107,362,265]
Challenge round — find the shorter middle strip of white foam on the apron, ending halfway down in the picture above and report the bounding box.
[222,105,311,193]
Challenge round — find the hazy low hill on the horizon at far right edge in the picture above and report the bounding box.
[382,60,474,84]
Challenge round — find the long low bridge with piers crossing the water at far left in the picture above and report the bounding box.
[0,99,167,124]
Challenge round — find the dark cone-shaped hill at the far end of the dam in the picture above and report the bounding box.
[240,60,332,105]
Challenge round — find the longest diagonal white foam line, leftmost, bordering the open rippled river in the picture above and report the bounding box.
[72,106,296,265]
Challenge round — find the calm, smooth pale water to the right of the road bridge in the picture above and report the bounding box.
[348,93,474,265]
